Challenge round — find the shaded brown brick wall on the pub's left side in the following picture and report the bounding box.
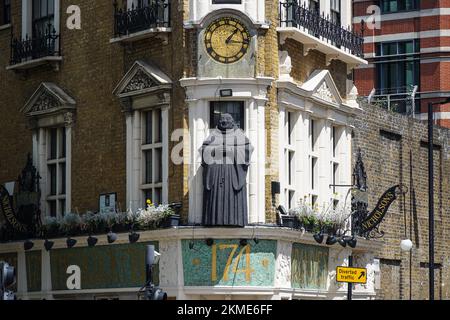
[0,0,187,213]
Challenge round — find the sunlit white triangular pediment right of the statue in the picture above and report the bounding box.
[301,70,343,105]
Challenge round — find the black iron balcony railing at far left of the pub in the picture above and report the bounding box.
[10,24,60,65]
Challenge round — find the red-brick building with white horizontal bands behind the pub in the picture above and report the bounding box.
[353,0,450,127]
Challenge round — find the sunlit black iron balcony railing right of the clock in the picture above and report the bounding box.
[280,0,364,58]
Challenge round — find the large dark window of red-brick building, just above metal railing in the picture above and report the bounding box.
[376,40,420,94]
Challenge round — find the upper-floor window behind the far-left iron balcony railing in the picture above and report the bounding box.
[32,0,55,38]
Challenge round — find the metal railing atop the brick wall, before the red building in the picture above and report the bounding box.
[367,86,420,117]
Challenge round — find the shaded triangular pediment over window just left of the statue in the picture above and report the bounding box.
[113,60,172,98]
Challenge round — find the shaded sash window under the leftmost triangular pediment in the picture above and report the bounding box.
[42,127,67,217]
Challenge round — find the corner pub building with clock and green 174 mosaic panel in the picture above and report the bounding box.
[0,0,400,300]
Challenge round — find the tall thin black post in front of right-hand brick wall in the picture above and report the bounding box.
[428,97,450,301]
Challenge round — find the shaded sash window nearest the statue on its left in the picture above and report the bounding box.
[141,108,164,205]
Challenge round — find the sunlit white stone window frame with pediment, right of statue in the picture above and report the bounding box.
[276,70,360,212]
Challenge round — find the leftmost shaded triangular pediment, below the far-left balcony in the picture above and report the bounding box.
[21,82,76,117]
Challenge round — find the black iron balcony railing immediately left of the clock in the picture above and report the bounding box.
[114,0,170,37]
